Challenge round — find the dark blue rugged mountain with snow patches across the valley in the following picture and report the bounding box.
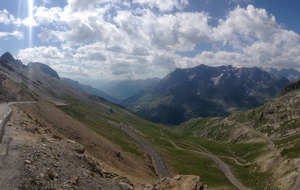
[122,65,289,125]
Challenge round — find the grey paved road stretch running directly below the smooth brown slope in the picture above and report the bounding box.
[120,125,170,178]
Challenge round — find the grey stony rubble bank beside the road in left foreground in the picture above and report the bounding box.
[0,106,133,190]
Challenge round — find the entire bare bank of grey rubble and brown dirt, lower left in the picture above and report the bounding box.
[0,103,157,189]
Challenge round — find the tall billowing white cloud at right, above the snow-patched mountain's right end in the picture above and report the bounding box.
[213,5,300,68]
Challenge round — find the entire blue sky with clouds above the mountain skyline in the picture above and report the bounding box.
[0,0,300,80]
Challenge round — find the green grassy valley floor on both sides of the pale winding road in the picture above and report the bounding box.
[57,91,272,189]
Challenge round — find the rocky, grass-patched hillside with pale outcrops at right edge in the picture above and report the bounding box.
[175,90,300,189]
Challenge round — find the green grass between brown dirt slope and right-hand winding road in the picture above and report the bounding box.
[61,98,239,188]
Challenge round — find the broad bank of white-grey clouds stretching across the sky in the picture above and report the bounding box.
[8,0,300,78]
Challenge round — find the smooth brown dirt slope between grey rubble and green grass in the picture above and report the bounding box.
[12,102,156,186]
